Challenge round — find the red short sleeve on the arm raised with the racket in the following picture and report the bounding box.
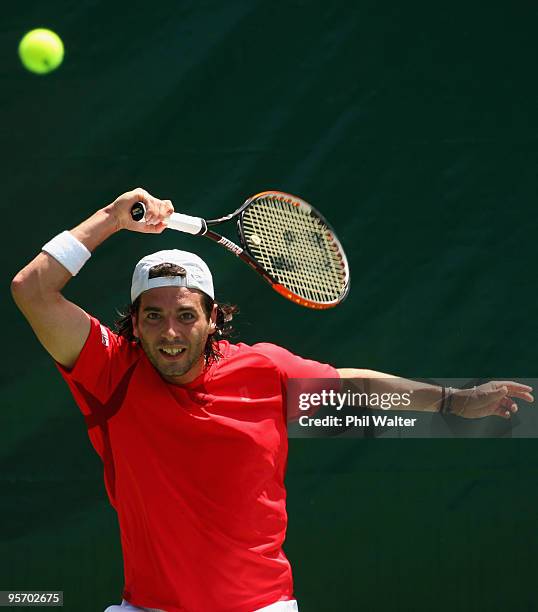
[56,317,140,413]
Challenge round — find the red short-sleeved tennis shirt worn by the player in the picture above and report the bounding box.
[59,318,338,612]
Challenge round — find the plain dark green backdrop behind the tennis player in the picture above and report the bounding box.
[0,0,538,612]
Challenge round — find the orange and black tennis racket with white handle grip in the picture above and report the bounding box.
[131,191,350,309]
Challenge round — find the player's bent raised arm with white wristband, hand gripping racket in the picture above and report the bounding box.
[11,188,174,368]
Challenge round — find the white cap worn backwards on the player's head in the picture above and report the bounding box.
[131,249,215,302]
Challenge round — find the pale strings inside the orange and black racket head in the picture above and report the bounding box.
[242,196,347,303]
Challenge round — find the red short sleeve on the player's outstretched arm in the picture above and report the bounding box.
[248,342,340,421]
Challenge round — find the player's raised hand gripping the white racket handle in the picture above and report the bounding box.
[107,187,174,234]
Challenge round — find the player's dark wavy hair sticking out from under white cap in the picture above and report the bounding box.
[114,263,239,365]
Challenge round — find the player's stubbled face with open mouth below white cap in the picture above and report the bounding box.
[133,287,217,385]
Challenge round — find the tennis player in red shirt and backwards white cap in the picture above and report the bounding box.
[12,189,532,612]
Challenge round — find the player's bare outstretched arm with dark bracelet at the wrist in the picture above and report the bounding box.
[338,368,534,419]
